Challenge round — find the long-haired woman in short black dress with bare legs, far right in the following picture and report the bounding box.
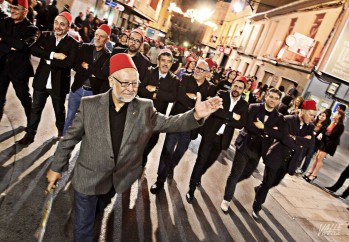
[303,110,345,182]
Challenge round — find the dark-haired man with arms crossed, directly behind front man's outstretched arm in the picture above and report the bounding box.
[138,49,179,166]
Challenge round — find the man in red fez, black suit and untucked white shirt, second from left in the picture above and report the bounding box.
[18,12,78,145]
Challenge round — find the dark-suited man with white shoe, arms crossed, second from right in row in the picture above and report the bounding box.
[221,88,283,212]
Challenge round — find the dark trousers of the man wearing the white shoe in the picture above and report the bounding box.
[224,150,260,201]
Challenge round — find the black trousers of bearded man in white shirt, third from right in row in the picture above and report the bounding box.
[189,135,222,192]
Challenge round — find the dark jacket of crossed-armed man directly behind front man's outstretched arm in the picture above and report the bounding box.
[138,67,179,114]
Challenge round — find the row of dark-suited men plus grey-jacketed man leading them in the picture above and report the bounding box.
[0,0,343,241]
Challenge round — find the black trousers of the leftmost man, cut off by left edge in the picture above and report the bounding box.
[0,71,32,125]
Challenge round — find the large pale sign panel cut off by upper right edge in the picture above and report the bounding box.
[322,17,349,82]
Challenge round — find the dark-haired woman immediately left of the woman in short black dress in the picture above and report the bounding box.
[297,109,331,175]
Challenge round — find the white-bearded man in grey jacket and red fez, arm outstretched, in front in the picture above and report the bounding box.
[47,54,222,242]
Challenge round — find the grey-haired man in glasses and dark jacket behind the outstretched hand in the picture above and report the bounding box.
[150,60,216,194]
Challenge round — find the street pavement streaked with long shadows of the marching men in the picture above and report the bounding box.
[0,59,349,242]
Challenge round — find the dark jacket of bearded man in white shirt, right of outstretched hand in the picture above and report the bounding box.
[202,91,248,150]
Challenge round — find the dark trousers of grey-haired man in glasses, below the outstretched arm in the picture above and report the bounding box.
[157,132,191,182]
